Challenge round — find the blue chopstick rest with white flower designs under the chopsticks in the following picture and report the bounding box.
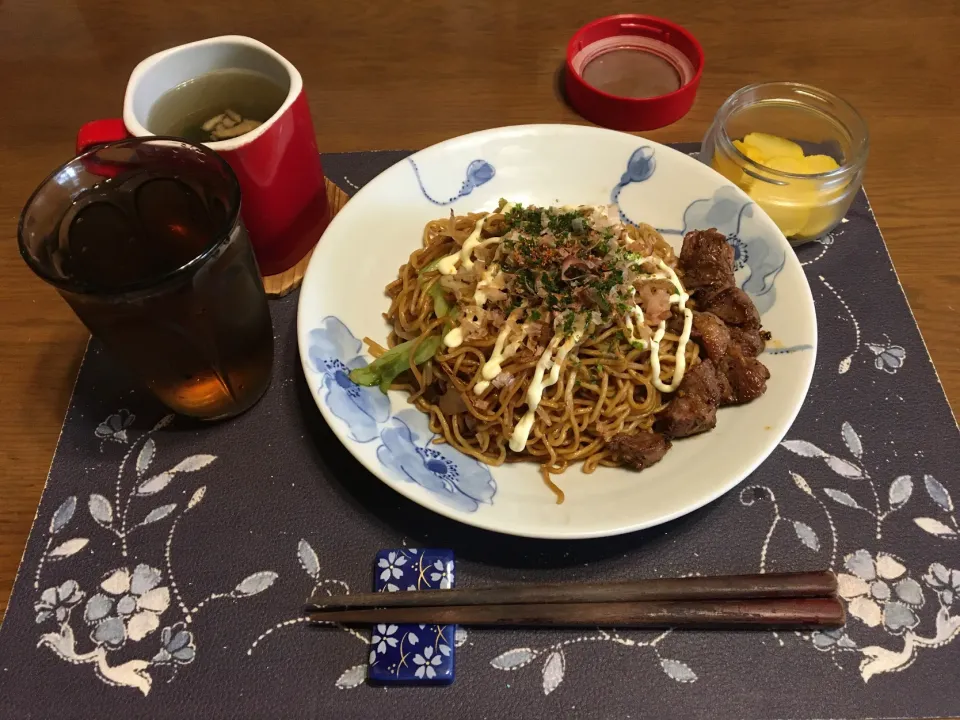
[368,548,457,685]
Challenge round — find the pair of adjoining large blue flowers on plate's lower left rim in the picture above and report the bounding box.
[307,315,497,512]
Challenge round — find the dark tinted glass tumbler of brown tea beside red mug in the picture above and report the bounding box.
[18,137,273,420]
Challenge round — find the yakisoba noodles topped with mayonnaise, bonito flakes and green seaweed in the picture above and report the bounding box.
[351,201,772,502]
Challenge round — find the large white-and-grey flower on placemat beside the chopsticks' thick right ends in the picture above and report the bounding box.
[837,550,923,633]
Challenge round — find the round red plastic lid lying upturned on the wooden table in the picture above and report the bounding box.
[565,15,703,130]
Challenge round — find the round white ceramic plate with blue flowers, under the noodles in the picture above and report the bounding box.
[297,125,817,538]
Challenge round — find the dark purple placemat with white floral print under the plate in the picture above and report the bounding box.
[0,147,960,719]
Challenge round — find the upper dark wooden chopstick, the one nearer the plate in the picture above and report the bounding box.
[307,571,837,611]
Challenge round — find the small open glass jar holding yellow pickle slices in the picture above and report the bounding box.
[700,82,869,245]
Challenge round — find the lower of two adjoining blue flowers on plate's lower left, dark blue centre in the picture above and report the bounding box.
[377,410,497,512]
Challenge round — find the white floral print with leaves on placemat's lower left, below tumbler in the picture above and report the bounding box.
[33,410,277,695]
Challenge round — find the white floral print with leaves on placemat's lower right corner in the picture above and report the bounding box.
[741,422,960,682]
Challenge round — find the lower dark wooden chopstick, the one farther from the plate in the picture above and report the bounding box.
[308,593,846,630]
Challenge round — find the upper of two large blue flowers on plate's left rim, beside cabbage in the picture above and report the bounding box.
[307,316,390,443]
